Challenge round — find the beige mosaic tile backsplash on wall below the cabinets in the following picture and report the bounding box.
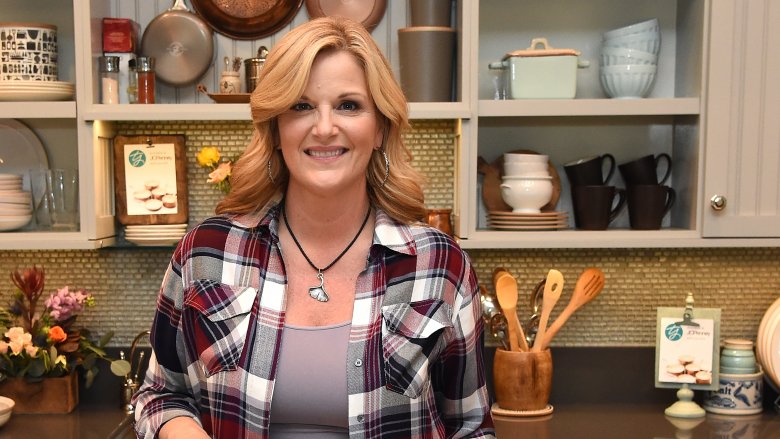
[0,121,780,346]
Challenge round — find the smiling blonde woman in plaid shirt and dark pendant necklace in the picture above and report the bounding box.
[134,18,494,439]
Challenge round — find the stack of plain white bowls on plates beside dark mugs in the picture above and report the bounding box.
[501,154,553,214]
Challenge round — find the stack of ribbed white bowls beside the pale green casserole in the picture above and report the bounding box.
[600,18,661,99]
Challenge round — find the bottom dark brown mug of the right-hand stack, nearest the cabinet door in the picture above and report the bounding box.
[626,184,676,230]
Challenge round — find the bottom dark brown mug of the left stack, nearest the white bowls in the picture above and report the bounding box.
[571,185,626,230]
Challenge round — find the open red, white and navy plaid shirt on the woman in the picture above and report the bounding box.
[133,203,494,439]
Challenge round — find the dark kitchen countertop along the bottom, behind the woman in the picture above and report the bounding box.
[0,404,780,439]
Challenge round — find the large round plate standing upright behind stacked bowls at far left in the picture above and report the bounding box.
[0,119,49,191]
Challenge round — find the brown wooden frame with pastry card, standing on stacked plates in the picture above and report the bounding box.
[114,135,189,225]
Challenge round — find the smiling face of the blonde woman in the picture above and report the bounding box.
[278,51,382,195]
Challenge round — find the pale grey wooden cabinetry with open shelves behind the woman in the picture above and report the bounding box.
[0,0,780,248]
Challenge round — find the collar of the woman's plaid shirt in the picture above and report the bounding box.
[233,195,417,255]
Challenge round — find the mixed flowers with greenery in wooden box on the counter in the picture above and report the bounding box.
[0,267,123,387]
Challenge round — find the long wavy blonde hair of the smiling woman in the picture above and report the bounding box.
[216,17,425,224]
